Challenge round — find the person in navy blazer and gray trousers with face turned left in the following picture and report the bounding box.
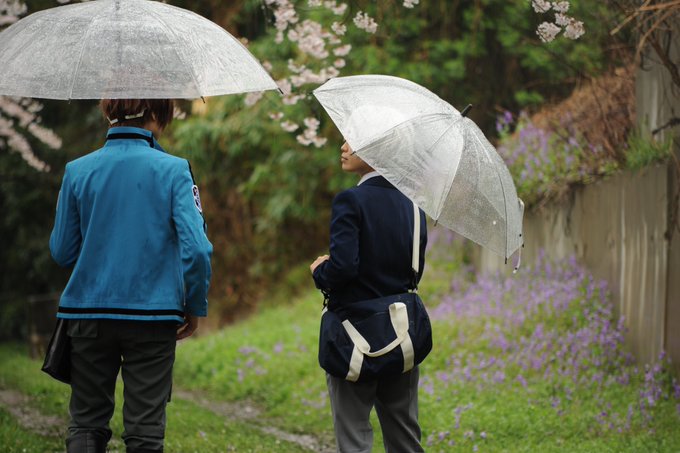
[310,139,427,453]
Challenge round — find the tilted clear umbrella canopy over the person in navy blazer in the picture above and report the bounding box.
[314,75,524,258]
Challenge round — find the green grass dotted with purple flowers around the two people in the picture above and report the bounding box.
[0,235,680,453]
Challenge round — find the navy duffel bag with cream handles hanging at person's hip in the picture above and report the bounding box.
[319,292,432,382]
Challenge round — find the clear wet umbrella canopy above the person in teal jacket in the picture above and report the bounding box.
[0,0,278,99]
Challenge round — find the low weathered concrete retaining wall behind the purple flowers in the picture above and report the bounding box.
[474,165,668,362]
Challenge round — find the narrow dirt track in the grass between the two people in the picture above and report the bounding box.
[173,390,335,453]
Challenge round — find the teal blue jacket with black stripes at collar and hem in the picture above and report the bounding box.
[50,127,212,322]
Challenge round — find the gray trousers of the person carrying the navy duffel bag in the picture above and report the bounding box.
[326,367,424,453]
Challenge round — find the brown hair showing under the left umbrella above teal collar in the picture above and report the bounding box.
[99,99,175,129]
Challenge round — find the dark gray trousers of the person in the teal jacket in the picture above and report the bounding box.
[68,319,177,450]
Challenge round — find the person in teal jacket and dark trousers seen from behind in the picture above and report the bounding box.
[50,99,212,453]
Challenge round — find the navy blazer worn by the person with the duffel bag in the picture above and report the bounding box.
[314,176,427,308]
